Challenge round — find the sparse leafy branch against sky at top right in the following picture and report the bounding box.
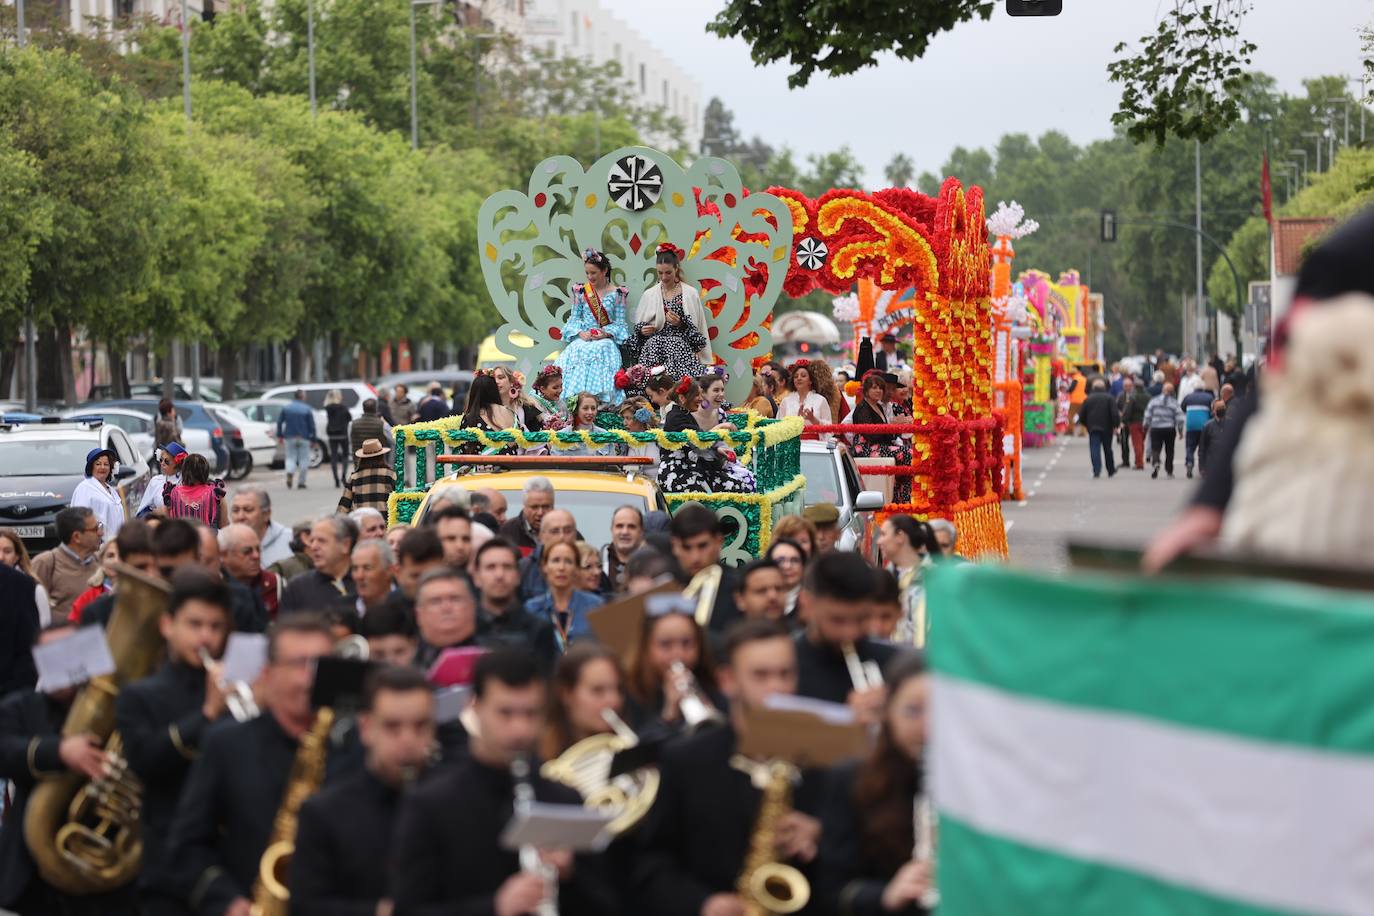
[1107,0,1254,146]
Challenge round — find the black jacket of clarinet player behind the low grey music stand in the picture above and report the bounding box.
[392,754,620,916]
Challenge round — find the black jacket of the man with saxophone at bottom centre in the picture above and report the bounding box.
[633,725,823,916]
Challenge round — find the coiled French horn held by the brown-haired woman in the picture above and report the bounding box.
[540,709,658,836]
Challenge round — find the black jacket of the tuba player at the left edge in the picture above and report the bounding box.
[0,691,67,906]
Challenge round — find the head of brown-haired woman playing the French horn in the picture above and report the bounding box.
[540,641,625,759]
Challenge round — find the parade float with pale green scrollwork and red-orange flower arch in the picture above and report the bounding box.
[392,147,1006,556]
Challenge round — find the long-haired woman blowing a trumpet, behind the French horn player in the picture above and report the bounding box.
[625,603,724,732]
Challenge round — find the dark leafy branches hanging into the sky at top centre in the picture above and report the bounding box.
[706,0,998,88]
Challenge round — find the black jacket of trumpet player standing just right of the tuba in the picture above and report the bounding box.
[114,662,210,887]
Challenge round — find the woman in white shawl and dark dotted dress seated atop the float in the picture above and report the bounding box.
[635,244,713,379]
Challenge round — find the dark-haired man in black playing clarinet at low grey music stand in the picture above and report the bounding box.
[392,647,618,916]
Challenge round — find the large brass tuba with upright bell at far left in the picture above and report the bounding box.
[23,564,168,897]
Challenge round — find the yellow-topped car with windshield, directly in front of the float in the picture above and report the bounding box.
[411,460,668,544]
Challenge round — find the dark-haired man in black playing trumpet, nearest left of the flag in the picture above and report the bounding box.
[797,552,896,722]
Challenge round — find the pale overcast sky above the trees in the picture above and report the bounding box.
[600,0,1374,187]
